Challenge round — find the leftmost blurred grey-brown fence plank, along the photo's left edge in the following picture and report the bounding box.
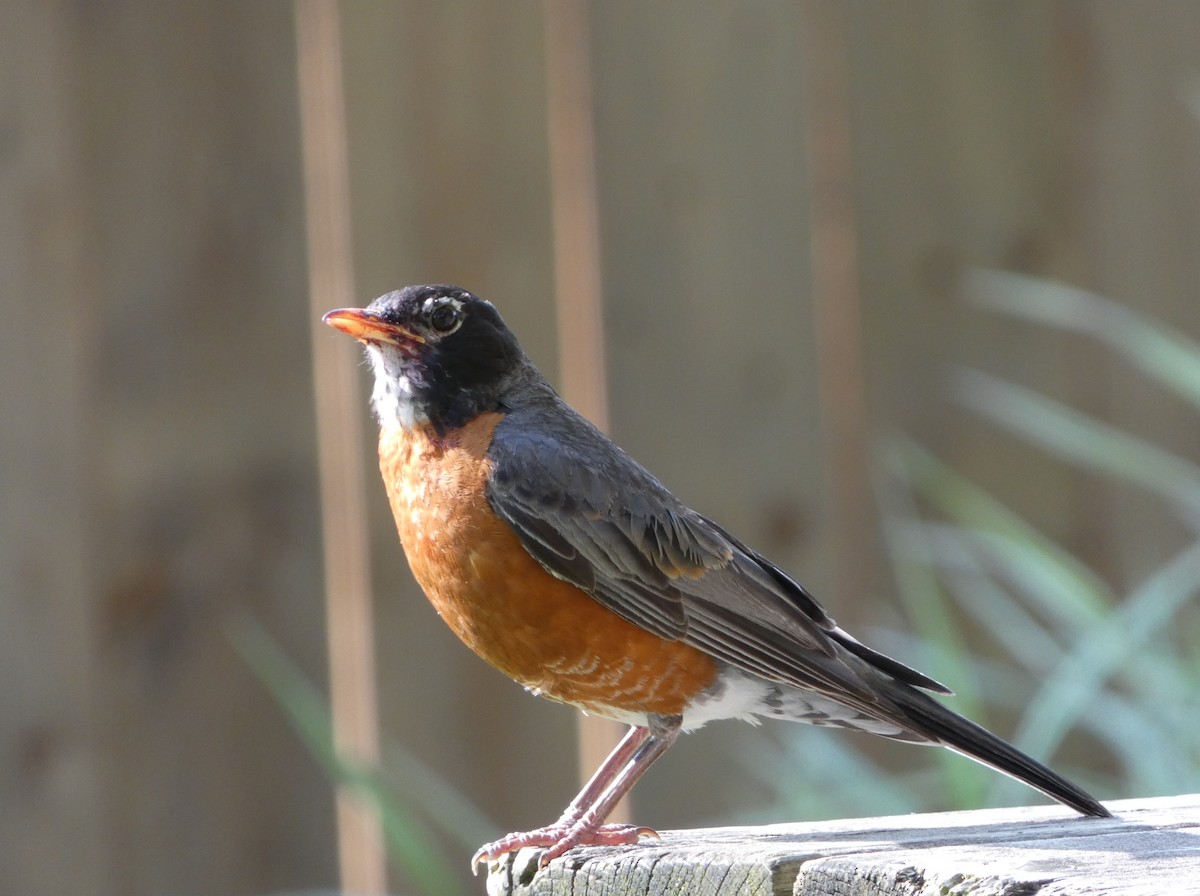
[0,2,104,896]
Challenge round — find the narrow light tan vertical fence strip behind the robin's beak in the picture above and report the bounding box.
[295,0,386,895]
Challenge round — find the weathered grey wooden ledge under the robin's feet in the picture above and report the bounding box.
[487,794,1200,896]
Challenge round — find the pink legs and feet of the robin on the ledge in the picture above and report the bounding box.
[470,716,680,871]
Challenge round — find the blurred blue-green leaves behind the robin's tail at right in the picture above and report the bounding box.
[745,271,1200,817]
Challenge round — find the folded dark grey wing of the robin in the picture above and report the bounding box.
[487,405,948,698]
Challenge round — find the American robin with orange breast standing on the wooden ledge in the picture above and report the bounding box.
[324,285,1109,868]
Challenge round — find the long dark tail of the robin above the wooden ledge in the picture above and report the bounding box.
[888,686,1111,818]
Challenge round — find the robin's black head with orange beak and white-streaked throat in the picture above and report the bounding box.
[323,285,528,431]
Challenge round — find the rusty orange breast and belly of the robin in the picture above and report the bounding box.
[379,414,716,721]
